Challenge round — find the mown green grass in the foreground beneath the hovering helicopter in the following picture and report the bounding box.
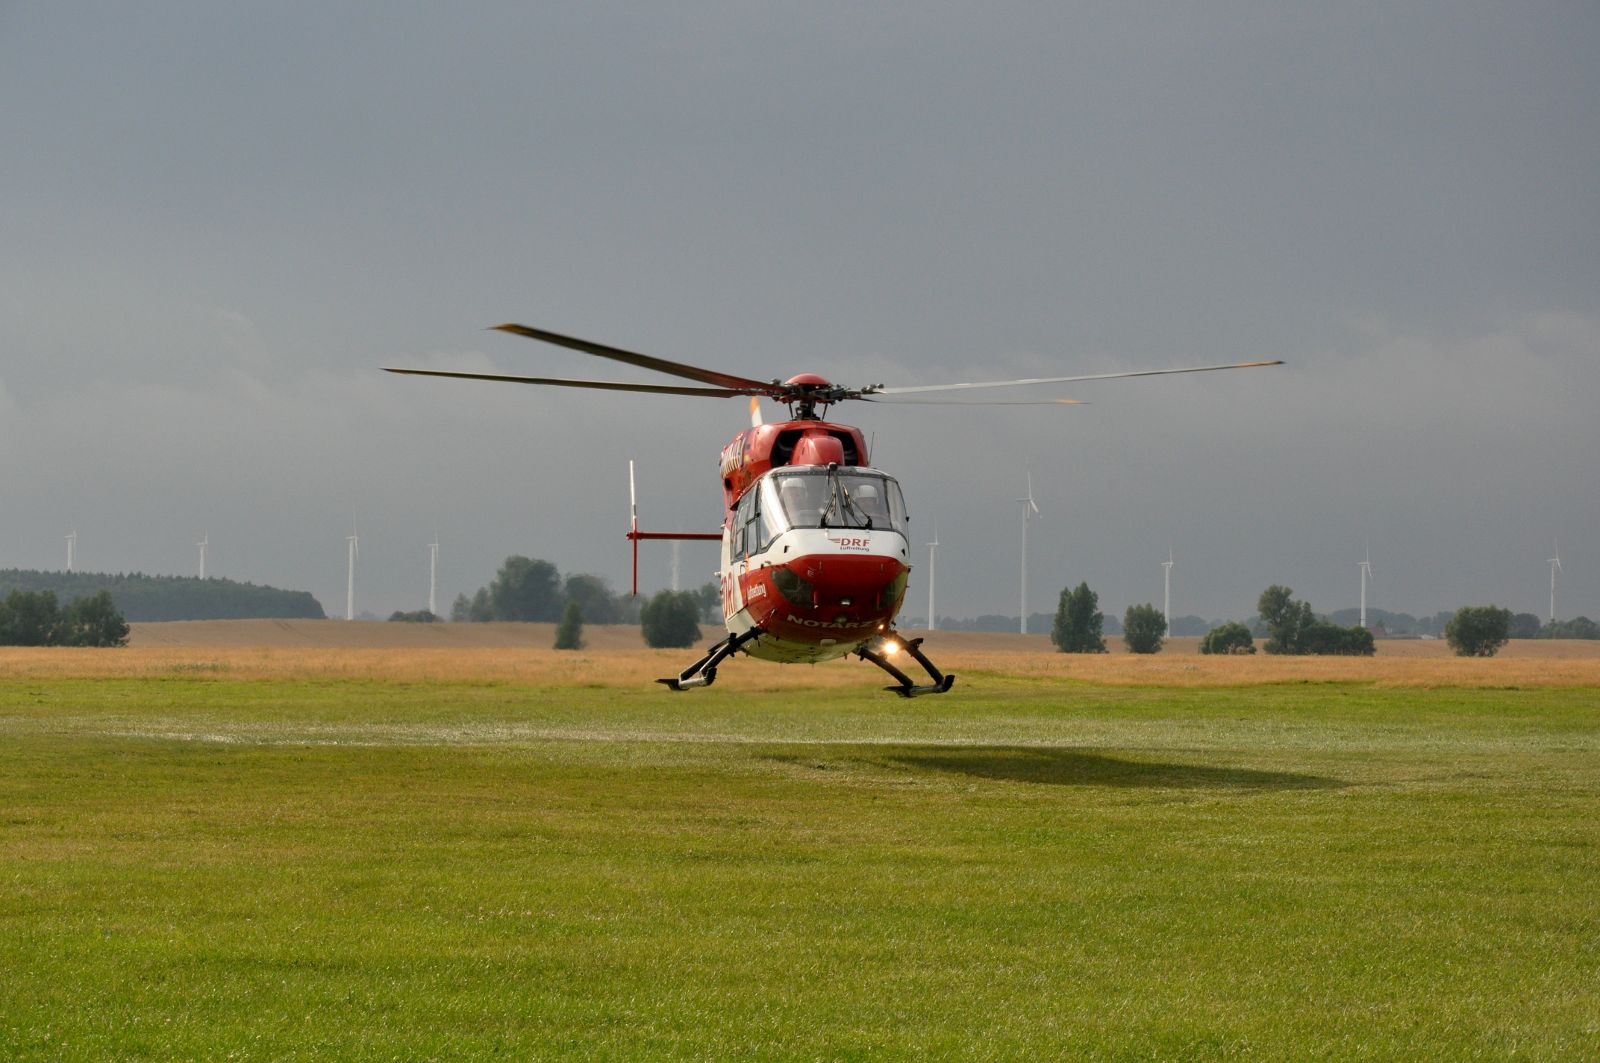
[0,671,1600,1060]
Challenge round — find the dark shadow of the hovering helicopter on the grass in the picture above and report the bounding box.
[773,744,1346,791]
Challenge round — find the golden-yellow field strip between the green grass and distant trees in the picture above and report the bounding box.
[0,621,1600,690]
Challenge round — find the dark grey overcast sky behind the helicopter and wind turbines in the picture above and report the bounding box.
[0,0,1600,618]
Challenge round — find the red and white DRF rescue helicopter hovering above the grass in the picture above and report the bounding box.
[386,323,1283,698]
